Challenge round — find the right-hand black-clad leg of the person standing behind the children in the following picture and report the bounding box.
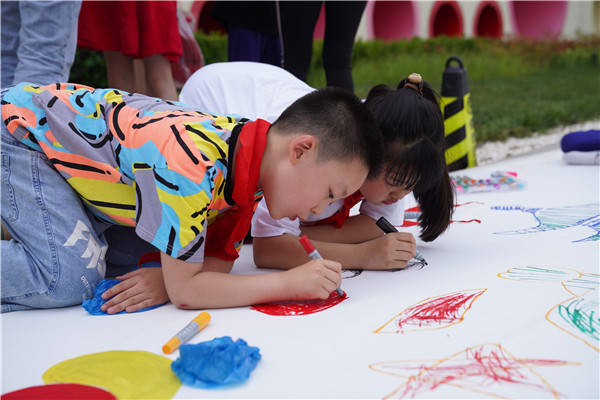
[323,1,367,92]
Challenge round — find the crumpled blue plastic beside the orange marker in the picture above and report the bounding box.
[171,336,261,389]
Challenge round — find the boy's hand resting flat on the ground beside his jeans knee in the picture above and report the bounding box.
[100,267,169,314]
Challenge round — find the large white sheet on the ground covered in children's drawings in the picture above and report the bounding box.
[2,150,600,399]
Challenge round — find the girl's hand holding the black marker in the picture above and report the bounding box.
[359,232,417,270]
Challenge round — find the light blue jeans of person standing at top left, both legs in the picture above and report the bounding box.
[0,1,81,87]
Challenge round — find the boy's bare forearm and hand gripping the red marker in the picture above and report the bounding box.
[161,253,341,309]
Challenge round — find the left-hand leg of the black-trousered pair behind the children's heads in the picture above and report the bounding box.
[278,1,322,81]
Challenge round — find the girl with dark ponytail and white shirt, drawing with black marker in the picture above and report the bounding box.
[180,62,454,270]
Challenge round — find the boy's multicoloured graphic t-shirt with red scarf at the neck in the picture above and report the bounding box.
[2,83,269,262]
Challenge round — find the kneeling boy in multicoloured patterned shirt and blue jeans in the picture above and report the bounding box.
[1,83,381,312]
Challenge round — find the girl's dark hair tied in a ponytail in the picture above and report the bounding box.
[365,79,454,242]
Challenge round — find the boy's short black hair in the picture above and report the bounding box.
[273,87,383,179]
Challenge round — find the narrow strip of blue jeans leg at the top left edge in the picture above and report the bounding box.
[0,1,21,87]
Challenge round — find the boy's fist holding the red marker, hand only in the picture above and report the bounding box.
[284,260,342,300]
